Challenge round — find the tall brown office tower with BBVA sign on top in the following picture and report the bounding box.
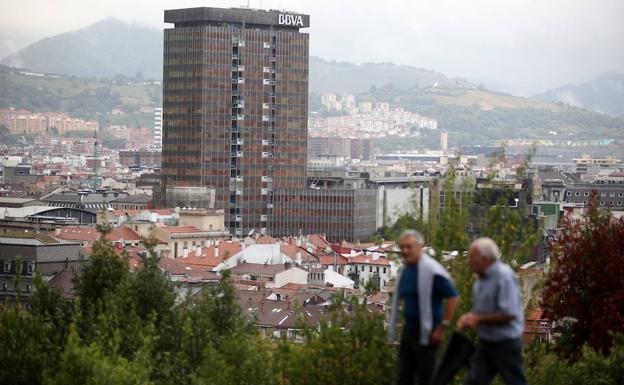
[162,8,310,235]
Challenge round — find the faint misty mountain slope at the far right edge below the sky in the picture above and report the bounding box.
[533,73,624,116]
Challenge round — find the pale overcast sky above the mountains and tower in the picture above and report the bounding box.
[0,0,624,95]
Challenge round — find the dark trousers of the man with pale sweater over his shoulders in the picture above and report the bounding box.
[398,331,438,385]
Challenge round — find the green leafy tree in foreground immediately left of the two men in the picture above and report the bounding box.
[276,295,396,385]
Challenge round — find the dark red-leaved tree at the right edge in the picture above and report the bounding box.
[542,191,624,357]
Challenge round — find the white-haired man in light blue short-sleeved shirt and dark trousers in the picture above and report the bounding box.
[457,238,527,385]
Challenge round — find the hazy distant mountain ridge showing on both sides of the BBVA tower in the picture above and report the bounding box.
[1,18,475,93]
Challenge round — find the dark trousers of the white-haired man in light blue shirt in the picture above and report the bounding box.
[464,338,527,385]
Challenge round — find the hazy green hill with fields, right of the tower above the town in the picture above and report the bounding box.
[359,85,624,144]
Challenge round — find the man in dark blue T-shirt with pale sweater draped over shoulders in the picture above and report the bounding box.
[388,230,459,385]
